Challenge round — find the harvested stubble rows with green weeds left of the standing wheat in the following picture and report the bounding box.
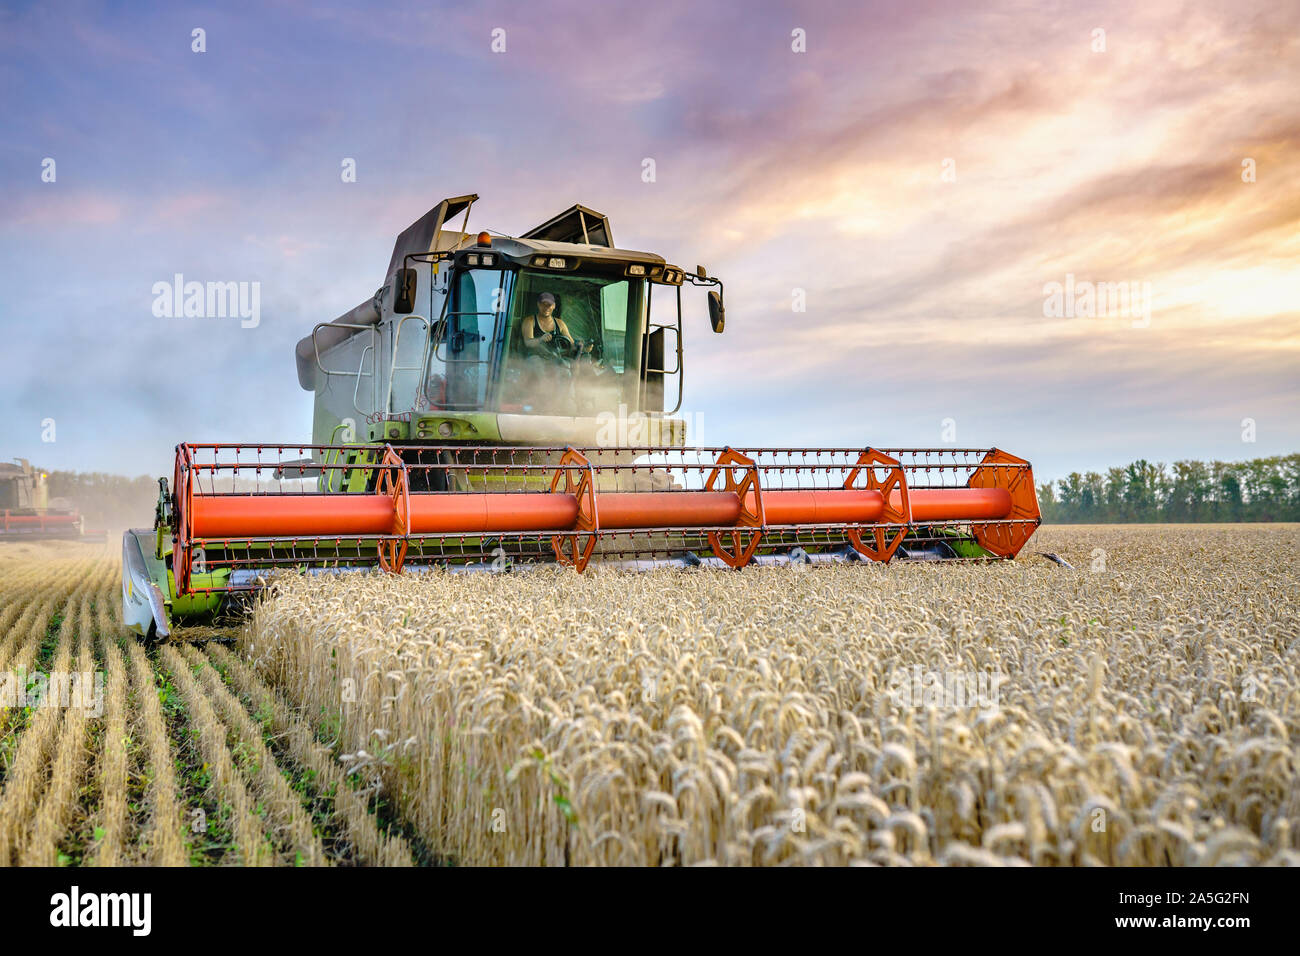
[0,542,416,866]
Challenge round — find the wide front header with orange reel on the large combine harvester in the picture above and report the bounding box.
[124,445,1040,632]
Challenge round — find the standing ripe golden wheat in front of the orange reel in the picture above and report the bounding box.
[242,525,1300,865]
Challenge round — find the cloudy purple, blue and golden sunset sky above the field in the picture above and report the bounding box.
[0,0,1300,481]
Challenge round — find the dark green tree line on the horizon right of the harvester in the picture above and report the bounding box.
[1037,454,1300,524]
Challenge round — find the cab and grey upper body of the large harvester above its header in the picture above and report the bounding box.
[296,195,724,455]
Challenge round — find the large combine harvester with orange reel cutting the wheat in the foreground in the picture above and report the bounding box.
[122,195,1040,637]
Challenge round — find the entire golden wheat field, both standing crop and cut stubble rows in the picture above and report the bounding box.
[0,525,1300,866]
